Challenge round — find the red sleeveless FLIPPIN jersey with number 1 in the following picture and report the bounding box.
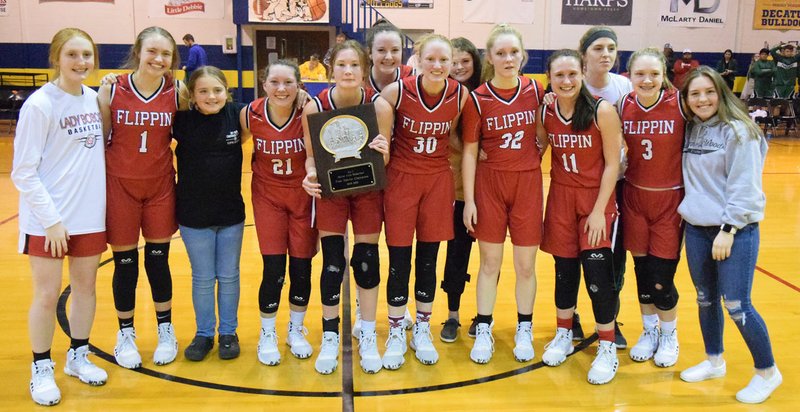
[106,74,178,179]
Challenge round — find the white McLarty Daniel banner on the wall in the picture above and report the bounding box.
[658,0,728,28]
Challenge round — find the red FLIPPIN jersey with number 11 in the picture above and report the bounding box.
[542,99,606,188]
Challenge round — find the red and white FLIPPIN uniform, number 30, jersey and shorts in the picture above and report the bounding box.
[384,76,463,246]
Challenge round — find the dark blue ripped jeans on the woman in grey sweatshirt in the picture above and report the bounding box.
[686,223,775,369]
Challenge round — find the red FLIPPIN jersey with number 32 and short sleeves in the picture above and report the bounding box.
[461,76,544,172]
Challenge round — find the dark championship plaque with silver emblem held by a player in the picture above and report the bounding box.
[308,103,386,197]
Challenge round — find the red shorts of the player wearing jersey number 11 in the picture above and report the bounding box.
[542,182,618,258]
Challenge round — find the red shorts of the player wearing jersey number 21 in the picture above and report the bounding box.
[252,178,317,258]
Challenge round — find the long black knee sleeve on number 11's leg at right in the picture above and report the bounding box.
[581,248,617,323]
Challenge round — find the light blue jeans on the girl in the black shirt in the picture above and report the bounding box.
[180,222,244,338]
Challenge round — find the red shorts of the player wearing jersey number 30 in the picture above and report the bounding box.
[383,168,455,246]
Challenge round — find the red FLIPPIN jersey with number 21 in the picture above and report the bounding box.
[246,97,306,187]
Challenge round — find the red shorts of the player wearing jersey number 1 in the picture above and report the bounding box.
[106,174,178,246]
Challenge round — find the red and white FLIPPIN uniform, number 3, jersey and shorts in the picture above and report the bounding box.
[619,89,686,259]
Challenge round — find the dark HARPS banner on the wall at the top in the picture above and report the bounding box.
[561,0,633,26]
